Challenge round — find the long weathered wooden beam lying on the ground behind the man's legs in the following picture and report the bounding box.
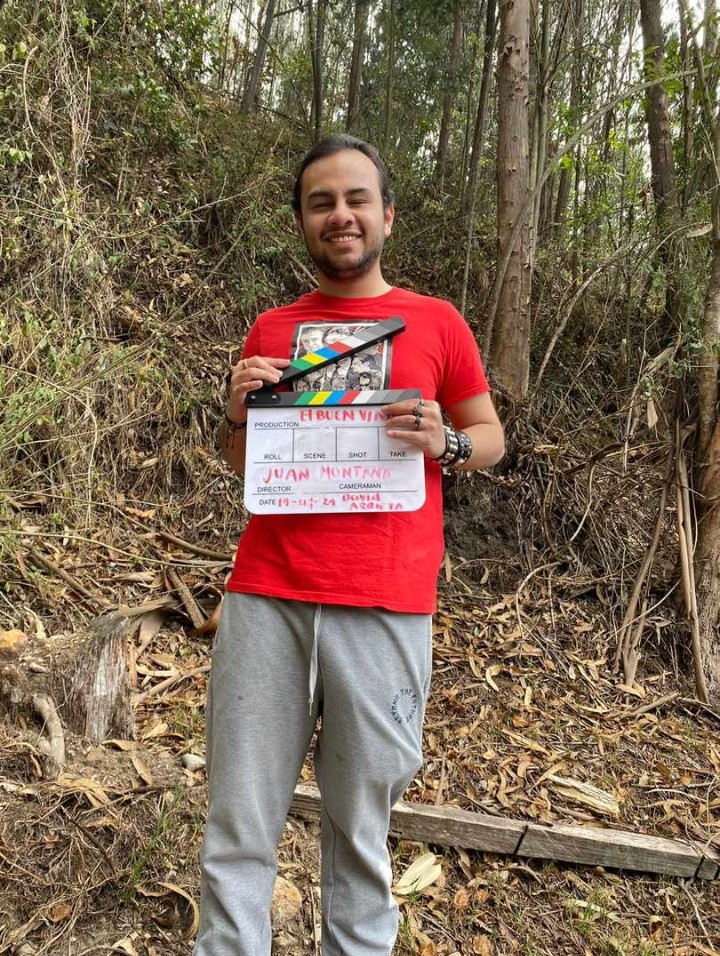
[291,784,720,880]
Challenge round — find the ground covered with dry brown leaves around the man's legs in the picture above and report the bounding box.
[0,508,720,956]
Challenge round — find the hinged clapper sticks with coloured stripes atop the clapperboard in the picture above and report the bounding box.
[245,315,404,408]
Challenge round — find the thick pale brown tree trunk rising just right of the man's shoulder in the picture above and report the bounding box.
[486,0,531,399]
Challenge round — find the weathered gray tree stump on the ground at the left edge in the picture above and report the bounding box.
[0,612,137,774]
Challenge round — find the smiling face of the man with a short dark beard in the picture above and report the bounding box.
[297,149,395,281]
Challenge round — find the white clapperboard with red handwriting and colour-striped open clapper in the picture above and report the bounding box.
[244,317,425,514]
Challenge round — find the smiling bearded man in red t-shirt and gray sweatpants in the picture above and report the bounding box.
[195,136,504,956]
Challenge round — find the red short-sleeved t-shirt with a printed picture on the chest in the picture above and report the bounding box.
[227,289,489,614]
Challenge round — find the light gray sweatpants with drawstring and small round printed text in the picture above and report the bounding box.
[195,593,431,956]
